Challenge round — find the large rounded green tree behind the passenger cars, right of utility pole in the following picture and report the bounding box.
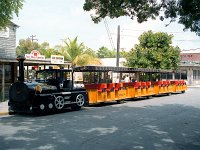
[126,31,180,69]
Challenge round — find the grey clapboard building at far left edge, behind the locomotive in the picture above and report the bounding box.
[0,22,18,101]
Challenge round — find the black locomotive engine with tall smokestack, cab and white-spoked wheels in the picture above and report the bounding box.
[8,57,87,113]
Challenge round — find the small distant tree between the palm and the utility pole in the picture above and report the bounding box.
[97,46,116,58]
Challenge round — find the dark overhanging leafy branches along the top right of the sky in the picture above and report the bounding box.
[83,0,200,35]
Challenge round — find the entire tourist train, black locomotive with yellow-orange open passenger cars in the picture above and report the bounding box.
[8,57,187,114]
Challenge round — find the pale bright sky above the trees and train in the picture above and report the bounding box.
[13,0,200,51]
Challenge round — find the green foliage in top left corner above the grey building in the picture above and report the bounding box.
[0,0,24,29]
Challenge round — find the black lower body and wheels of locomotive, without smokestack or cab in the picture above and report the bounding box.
[8,82,87,113]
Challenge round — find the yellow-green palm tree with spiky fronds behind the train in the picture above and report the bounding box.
[59,37,101,67]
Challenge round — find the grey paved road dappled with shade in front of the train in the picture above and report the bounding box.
[0,88,200,150]
